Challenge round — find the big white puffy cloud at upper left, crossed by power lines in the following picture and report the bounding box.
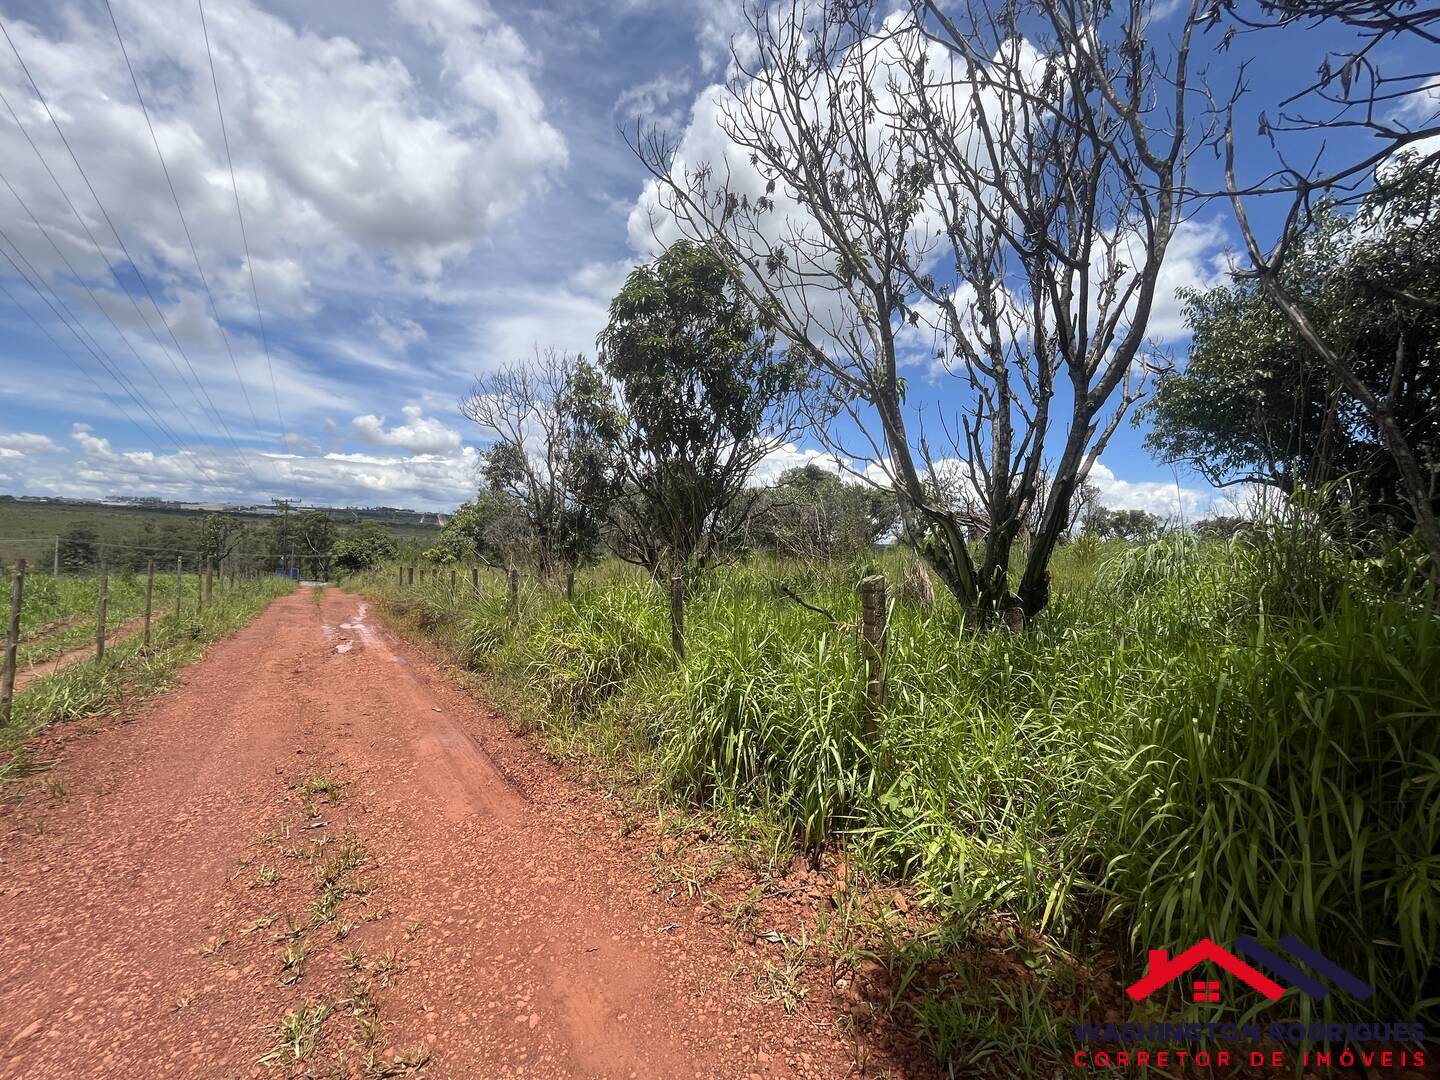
[0,0,566,296]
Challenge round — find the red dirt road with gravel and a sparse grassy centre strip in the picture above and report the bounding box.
[0,590,898,1080]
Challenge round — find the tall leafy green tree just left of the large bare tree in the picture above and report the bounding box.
[596,240,808,573]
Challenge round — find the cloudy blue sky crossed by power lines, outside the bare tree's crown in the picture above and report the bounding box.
[0,0,1405,516]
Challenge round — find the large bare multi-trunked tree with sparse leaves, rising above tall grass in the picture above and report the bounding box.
[635,0,1202,624]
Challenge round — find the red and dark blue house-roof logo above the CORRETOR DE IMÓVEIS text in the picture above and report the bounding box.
[1125,936,1374,1005]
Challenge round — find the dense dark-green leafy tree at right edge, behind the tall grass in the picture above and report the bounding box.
[1145,168,1440,544]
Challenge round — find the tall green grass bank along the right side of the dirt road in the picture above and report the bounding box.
[361,534,1440,1074]
